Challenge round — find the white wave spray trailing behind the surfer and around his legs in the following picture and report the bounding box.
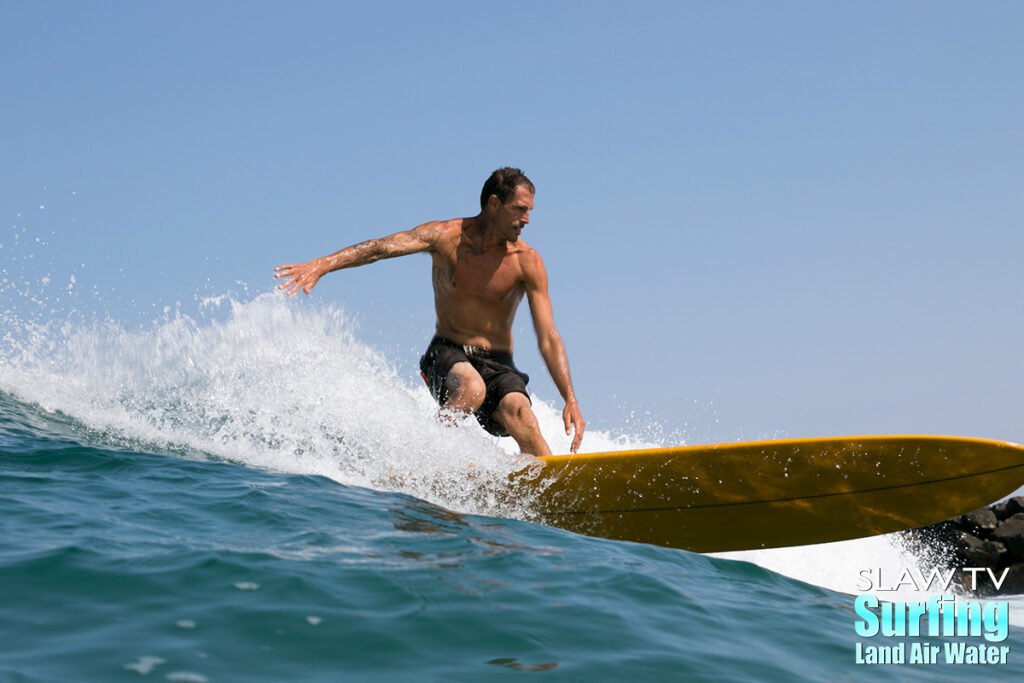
[0,293,655,516]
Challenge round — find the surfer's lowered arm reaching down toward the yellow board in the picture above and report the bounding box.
[523,252,587,453]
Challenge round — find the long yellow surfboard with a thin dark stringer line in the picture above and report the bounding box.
[521,436,1024,553]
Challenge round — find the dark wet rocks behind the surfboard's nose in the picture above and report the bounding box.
[902,496,1024,594]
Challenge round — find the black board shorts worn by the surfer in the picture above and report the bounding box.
[420,337,532,436]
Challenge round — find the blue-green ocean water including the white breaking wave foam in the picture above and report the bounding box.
[0,294,1024,682]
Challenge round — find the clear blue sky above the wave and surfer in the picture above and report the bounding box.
[0,0,1024,441]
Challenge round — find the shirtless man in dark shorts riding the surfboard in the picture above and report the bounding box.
[274,168,587,456]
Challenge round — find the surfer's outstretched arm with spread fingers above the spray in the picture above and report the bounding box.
[273,221,446,296]
